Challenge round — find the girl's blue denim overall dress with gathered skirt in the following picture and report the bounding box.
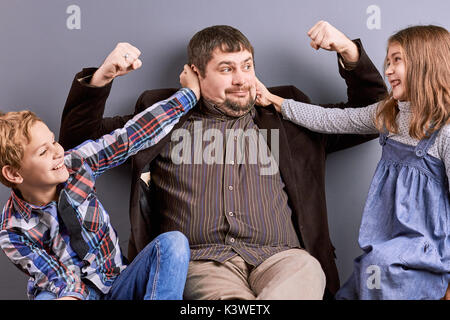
[336,130,450,300]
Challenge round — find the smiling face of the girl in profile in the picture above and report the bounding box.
[385,42,407,101]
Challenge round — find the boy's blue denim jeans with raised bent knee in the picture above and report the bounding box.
[35,231,190,300]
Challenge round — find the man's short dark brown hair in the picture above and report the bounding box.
[188,25,254,77]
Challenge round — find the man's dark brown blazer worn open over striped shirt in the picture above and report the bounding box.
[60,40,387,294]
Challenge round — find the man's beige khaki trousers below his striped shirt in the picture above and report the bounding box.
[184,249,325,300]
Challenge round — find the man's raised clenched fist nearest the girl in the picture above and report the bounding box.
[308,21,359,62]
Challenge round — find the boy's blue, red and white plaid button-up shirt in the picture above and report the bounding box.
[0,88,197,299]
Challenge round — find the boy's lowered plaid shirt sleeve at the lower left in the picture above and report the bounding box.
[0,229,88,300]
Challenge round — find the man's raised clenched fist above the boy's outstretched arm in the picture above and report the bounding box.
[90,42,142,87]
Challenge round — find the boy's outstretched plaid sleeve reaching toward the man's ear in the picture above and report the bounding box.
[72,88,197,178]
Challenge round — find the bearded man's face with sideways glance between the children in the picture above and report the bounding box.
[199,48,256,117]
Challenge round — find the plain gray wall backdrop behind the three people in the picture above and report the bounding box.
[0,0,450,299]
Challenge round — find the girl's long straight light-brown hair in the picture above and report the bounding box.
[375,25,450,140]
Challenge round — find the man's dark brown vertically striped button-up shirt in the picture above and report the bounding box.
[151,102,300,266]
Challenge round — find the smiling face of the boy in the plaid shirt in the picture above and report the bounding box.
[17,121,69,191]
